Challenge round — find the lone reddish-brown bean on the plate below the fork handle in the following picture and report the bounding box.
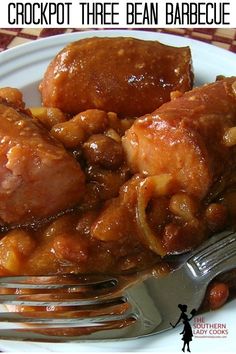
[207,282,229,310]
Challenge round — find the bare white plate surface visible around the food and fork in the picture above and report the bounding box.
[0,30,236,353]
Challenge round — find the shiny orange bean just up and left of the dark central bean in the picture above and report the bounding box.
[51,120,86,148]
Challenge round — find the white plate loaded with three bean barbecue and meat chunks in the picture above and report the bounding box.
[0,30,236,352]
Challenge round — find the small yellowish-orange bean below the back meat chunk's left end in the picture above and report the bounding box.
[30,107,66,129]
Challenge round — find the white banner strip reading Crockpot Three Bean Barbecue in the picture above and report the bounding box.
[0,0,236,28]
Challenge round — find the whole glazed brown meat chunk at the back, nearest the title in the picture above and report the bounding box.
[40,37,193,117]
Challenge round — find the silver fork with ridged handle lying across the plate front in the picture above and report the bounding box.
[0,231,236,342]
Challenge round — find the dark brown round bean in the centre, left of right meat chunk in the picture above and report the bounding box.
[83,134,124,169]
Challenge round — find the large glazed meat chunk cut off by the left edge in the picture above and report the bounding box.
[0,101,84,224]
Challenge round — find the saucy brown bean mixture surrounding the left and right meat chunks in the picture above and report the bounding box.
[0,79,236,308]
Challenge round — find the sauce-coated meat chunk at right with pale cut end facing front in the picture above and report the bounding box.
[123,77,236,199]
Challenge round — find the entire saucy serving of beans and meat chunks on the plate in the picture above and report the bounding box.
[0,38,236,310]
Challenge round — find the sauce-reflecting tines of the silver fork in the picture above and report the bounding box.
[0,274,136,339]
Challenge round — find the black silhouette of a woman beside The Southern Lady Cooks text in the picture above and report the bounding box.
[170,304,196,352]
